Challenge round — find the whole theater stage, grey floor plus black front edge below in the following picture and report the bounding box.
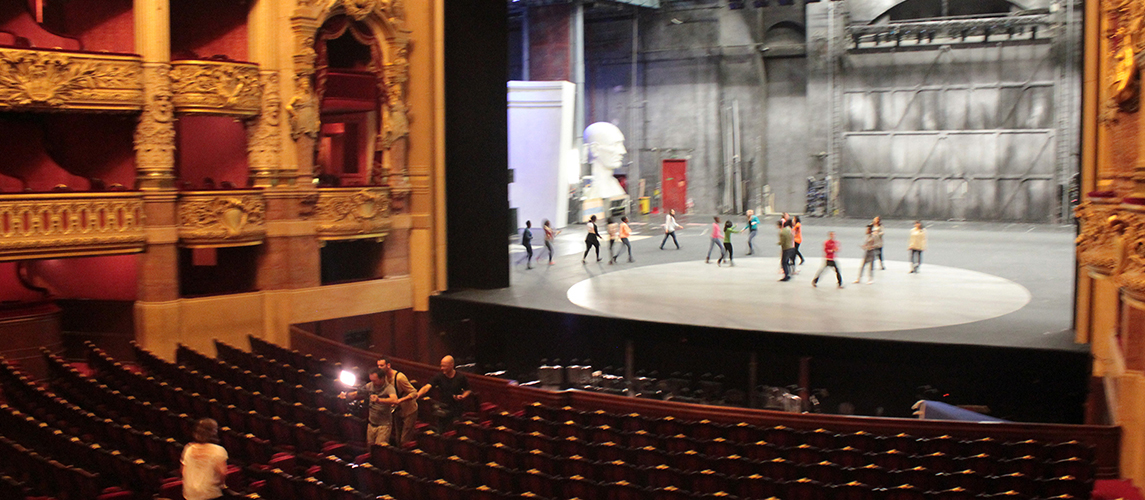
[432,216,1089,421]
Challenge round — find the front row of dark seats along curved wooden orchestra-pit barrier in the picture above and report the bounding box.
[524,403,1095,460]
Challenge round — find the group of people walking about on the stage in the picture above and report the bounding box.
[521,209,926,284]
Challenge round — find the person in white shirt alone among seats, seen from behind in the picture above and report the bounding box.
[181,419,228,500]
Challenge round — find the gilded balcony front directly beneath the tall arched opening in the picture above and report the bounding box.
[314,186,390,240]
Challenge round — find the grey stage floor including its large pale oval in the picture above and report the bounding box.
[447,216,1088,351]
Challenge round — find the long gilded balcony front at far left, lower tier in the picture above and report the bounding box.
[0,192,147,261]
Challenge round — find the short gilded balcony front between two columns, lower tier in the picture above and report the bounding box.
[179,189,267,248]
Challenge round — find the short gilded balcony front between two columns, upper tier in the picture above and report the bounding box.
[171,59,262,117]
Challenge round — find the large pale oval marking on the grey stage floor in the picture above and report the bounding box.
[568,257,1031,334]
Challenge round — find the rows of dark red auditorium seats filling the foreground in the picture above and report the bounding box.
[0,331,1096,500]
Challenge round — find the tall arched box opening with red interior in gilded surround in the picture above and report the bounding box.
[315,16,382,186]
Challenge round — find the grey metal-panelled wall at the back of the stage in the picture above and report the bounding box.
[549,0,1081,222]
